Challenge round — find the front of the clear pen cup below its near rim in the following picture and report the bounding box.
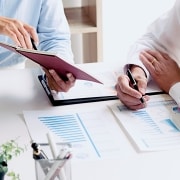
[35,158,71,180]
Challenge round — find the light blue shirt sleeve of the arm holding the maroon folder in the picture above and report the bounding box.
[37,0,73,62]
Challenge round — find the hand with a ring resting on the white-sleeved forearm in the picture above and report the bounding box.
[140,50,180,93]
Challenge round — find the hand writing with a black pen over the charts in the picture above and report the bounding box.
[116,66,149,110]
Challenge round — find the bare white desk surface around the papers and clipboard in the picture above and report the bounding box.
[0,63,180,180]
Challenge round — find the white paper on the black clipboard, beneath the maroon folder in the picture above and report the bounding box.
[52,71,117,100]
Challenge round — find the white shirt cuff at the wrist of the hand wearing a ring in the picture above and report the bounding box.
[169,82,180,107]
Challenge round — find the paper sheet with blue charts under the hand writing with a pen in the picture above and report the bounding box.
[110,95,180,151]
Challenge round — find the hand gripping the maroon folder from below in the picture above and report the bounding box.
[43,68,75,92]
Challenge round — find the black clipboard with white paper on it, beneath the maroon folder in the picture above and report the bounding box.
[39,70,118,106]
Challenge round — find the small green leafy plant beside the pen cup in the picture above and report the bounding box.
[0,139,24,180]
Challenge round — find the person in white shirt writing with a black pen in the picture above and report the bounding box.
[116,0,180,110]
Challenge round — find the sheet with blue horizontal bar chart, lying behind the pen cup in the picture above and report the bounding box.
[23,106,122,160]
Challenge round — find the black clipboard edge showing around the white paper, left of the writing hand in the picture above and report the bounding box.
[38,75,118,106]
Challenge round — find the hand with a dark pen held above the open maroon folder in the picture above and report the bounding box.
[0,16,38,49]
